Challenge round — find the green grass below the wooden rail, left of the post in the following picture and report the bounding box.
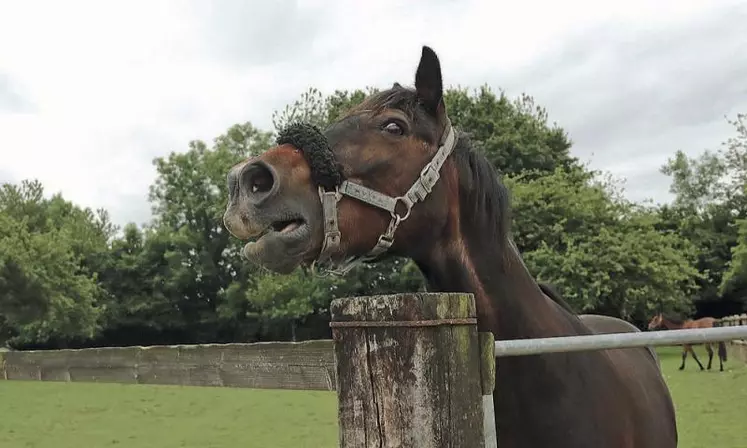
[0,381,337,448]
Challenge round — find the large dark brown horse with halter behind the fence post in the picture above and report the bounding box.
[224,47,677,448]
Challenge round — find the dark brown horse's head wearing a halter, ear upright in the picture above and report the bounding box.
[224,47,457,273]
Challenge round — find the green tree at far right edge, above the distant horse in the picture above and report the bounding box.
[660,114,747,314]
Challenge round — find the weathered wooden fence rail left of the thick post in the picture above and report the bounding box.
[0,340,337,391]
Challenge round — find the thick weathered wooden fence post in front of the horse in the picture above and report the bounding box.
[330,293,485,448]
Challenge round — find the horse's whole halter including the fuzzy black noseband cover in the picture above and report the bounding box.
[277,118,457,276]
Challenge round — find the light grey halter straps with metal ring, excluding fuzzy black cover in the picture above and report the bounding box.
[311,118,457,276]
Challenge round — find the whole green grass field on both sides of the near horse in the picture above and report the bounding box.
[0,348,747,448]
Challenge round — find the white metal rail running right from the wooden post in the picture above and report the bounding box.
[495,325,747,357]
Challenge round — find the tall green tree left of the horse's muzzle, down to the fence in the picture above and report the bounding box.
[93,123,270,343]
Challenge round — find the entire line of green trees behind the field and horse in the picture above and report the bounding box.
[0,86,747,349]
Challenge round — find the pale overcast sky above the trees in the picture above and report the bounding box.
[0,0,747,224]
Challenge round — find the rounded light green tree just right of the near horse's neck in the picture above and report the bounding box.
[506,168,699,321]
